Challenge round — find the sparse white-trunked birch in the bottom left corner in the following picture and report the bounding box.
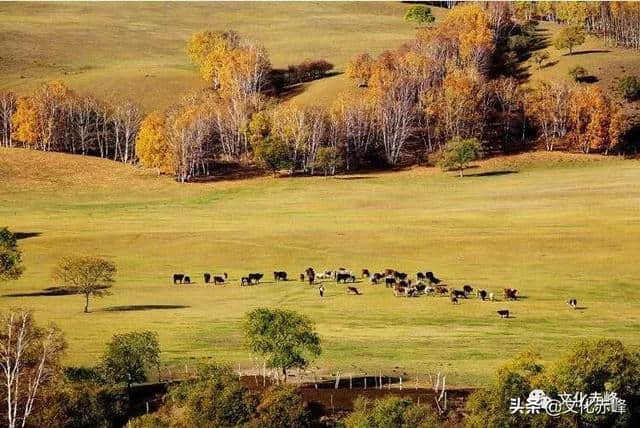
[0,309,65,428]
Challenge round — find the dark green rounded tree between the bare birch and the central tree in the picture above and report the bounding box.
[102,331,160,389]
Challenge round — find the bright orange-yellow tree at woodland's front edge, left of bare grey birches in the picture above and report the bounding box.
[135,111,175,175]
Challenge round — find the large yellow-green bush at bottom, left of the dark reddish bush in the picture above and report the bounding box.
[169,365,258,427]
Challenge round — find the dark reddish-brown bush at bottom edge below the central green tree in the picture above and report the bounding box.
[248,386,311,428]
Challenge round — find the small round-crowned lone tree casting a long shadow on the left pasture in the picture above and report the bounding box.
[53,256,116,313]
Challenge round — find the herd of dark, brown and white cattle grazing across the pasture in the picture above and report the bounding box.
[173,267,578,318]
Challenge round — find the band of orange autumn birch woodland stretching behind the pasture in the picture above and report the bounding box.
[0,2,633,182]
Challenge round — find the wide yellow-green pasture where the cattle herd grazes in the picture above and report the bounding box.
[0,149,640,385]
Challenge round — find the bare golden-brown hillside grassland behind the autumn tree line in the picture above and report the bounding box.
[0,2,444,111]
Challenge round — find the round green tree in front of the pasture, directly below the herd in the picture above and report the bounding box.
[243,308,322,381]
